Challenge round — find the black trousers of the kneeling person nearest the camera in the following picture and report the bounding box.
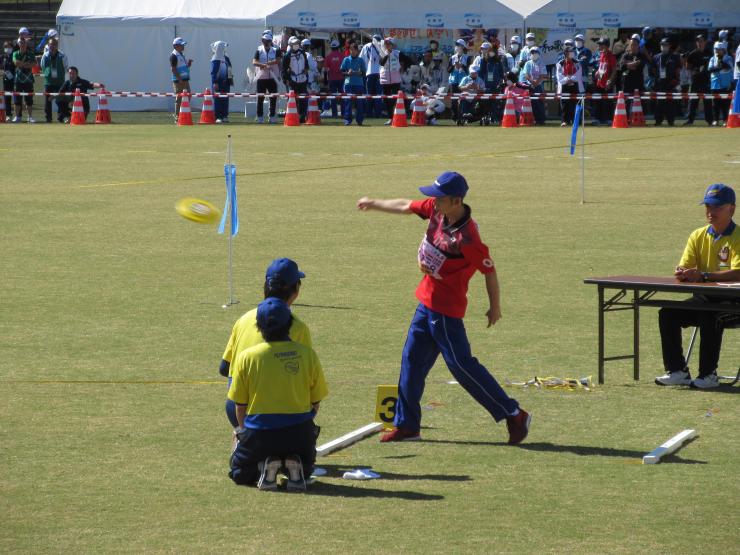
[229,420,318,486]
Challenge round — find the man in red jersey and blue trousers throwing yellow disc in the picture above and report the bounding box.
[357,172,531,445]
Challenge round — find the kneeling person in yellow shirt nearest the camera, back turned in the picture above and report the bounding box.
[229,297,328,490]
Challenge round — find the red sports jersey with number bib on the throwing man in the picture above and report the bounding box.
[411,198,495,318]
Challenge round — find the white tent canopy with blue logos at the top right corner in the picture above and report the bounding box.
[502,0,740,29]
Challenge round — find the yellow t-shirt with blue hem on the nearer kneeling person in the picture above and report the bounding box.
[228,341,328,429]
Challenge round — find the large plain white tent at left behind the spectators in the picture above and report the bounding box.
[57,0,290,110]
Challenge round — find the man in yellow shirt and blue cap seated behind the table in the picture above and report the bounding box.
[655,183,740,389]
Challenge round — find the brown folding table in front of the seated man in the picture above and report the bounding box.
[583,276,740,384]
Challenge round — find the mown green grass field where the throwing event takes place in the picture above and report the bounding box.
[0,118,740,554]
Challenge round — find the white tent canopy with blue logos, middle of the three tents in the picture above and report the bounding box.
[267,0,522,30]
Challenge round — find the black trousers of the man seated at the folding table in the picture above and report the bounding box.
[658,302,724,376]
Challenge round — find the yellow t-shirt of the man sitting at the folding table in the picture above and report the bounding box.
[678,224,740,272]
